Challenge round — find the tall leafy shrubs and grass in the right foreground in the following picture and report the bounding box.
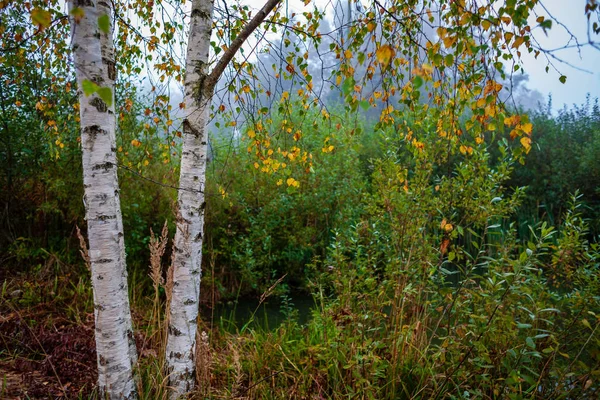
[193,104,600,399]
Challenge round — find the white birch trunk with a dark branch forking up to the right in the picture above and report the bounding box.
[166,0,281,399]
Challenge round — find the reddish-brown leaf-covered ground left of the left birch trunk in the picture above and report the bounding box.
[0,272,97,399]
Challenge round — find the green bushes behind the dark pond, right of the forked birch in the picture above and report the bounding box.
[204,104,365,293]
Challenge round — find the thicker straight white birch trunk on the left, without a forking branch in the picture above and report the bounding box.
[68,0,137,399]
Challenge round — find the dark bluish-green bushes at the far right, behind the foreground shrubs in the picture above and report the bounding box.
[510,98,600,236]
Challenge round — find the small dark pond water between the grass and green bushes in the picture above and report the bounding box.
[200,293,315,332]
